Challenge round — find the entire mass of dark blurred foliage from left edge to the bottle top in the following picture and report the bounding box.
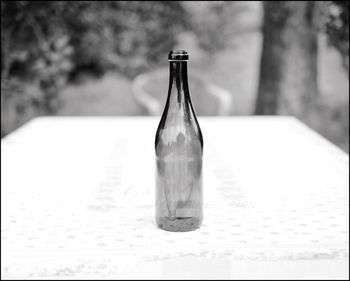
[1,1,188,135]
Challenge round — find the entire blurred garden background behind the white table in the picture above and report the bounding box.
[1,1,349,152]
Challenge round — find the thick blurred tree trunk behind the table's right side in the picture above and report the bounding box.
[255,1,317,119]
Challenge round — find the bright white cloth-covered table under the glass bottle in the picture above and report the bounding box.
[1,117,349,279]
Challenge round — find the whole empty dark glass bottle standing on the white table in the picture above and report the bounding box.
[155,51,203,231]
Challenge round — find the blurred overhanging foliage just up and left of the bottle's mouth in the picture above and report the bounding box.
[67,1,187,77]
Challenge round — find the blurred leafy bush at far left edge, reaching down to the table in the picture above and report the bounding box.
[1,1,76,136]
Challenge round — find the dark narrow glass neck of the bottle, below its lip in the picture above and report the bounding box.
[168,61,189,105]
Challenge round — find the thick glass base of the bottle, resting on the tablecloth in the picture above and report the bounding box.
[157,217,201,232]
